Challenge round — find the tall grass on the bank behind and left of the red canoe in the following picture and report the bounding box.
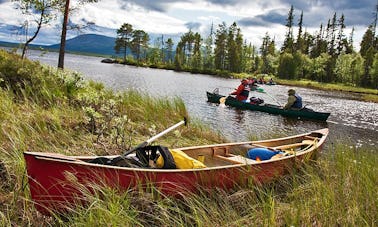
[0,50,224,225]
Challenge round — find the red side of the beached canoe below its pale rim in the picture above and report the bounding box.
[25,153,300,214]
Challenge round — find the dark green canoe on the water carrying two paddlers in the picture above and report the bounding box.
[207,92,330,121]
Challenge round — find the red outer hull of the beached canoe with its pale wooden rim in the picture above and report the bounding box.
[24,130,328,215]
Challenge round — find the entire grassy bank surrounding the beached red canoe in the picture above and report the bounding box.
[0,50,378,226]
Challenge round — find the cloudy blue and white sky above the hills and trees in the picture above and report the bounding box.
[0,0,378,50]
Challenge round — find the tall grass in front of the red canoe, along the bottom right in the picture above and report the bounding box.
[55,144,378,226]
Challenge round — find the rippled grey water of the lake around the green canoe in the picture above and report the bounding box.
[29,52,378,150]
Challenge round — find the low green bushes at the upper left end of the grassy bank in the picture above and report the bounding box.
[0,50,82,105]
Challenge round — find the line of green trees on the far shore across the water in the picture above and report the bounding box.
[114,5,378,88]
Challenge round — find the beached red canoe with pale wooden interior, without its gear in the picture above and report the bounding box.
[24,128,328,214]
